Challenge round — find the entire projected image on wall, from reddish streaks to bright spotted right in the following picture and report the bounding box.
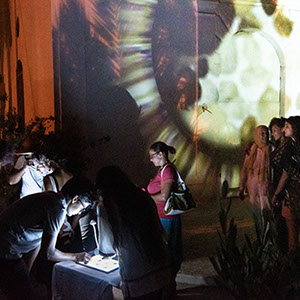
[53,0,300,193]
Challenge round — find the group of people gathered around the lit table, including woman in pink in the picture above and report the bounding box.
[0,138,182,299]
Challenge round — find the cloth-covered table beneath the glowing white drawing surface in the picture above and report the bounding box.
[52,261,120,300]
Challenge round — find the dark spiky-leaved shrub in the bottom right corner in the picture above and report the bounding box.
[210,200,300,299]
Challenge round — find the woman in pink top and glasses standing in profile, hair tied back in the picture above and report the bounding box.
[147,141,183,294]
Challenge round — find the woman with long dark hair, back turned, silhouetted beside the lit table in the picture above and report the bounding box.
[96,166,170,300]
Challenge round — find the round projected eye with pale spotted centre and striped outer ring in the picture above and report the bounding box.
[121,0,292,188]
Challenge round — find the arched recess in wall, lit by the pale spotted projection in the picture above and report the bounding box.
[219,29,285,125]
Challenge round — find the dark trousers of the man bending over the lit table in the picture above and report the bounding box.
[0,259,37,300]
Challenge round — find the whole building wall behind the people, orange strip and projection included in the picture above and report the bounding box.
[6,0,300,202]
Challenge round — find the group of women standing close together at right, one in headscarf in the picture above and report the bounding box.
[240,116,300,251]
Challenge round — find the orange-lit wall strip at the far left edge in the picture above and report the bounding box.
[2,0,54,122]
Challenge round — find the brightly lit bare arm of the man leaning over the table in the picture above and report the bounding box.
[40,232,91,262]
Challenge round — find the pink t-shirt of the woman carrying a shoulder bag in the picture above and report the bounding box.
[147,165,178,219]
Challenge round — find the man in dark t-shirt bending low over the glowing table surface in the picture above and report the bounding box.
[0,178,94,299]
